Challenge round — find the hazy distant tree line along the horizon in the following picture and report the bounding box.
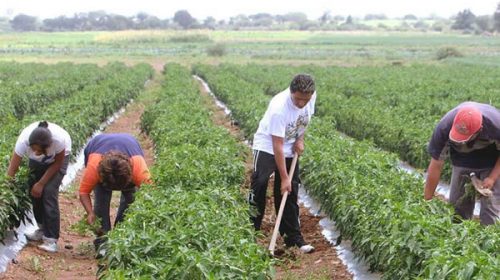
[0,3,500,33]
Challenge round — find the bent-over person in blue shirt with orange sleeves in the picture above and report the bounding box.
[80,133,150,253]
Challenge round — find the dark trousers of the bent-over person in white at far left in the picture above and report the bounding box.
[28,156,69,239]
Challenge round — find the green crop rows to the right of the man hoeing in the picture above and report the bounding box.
[194,65,500,279]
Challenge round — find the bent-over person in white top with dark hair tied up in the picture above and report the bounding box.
[7,121,71,252]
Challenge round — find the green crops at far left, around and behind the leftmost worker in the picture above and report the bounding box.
[0,63,153,239]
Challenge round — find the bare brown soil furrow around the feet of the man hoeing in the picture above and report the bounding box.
[195,77,353,280]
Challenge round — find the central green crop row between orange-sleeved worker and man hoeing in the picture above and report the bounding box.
[100,64,273,279]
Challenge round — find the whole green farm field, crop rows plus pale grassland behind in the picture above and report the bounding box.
[0,31,500,279]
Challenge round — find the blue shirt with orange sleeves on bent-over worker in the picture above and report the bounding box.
[80,133,151,194]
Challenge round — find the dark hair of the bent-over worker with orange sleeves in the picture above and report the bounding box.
[97,151,132,190]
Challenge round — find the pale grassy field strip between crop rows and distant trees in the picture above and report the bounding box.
[0,30,500,66]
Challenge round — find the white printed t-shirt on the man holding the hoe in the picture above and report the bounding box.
[253,88,316,157]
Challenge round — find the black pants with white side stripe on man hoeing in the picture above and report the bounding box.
[248,150,305,247]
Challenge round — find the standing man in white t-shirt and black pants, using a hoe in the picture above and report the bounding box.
[249,74,316,253]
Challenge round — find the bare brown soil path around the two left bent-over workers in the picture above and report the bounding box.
[0,76,156,280]
